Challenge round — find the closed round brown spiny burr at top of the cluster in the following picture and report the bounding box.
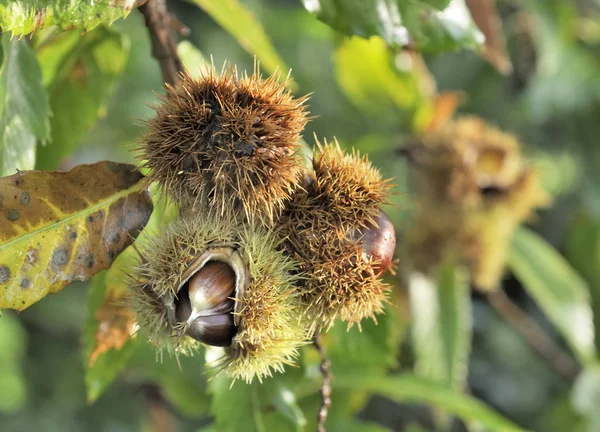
[140,66,307,219]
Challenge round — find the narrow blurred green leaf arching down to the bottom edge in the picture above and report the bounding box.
[332,374,524,432]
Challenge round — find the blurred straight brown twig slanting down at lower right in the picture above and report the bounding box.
[487,290,579,381]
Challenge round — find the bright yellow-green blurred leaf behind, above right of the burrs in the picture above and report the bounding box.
[334,37,431,131]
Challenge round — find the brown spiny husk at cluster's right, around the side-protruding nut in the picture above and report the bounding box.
[280,138,390,331]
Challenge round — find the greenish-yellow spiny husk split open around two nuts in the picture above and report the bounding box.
[130,214,306,381]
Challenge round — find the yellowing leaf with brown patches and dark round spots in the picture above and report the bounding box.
[0,162,152,310]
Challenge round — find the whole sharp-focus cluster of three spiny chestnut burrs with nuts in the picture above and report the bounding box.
[130,67,395,381]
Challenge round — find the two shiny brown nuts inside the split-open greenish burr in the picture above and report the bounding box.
[175,261,237,346]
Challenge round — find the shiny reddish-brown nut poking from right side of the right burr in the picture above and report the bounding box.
[353,210,396,275]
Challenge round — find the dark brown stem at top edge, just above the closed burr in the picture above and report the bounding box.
[139,0,183,85]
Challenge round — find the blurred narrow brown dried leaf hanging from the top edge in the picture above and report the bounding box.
[466,0,513,75]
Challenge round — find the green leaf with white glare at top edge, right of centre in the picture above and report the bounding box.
[303,0,484,52]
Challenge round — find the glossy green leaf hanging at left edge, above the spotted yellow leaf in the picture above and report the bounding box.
[0,35,50,176]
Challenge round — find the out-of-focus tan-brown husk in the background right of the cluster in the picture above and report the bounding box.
[406,117,549,290]
